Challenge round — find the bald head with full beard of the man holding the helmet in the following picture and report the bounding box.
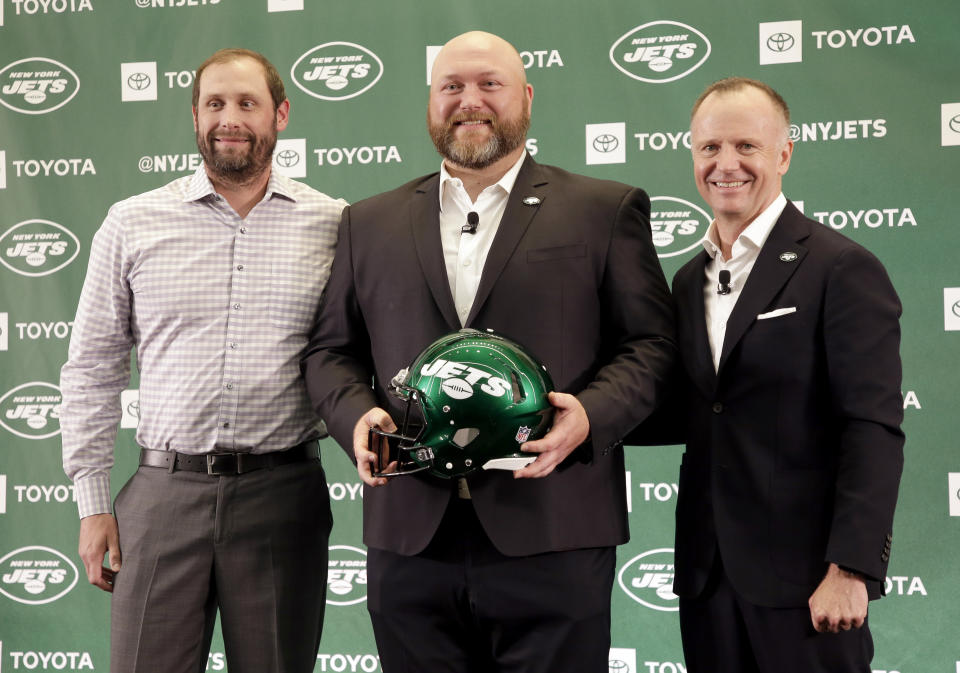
[427,32,533,170]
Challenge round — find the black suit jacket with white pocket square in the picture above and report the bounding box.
[673,203,904,607]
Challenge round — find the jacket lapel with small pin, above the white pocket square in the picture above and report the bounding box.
[720,202,809,370]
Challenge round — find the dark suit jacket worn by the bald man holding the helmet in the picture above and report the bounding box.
[304,157,675,555]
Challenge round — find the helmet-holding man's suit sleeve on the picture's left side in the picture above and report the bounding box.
[300,206,377,460]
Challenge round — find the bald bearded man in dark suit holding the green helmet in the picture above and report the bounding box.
[304,32,675,673]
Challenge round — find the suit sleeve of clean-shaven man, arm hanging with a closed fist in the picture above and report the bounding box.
[823,248,904,581]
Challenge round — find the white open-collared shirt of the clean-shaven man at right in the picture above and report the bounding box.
[702,192,787,371]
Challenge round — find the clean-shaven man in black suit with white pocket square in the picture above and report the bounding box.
[673,78,904,673]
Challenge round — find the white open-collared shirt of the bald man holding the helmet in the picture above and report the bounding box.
[440,150,527,326]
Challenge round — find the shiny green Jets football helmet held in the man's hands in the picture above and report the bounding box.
[369,329,553,478]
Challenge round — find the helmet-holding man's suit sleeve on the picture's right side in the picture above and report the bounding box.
[577,189,676,450]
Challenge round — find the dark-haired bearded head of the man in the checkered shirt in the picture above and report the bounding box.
[193,58,290,184]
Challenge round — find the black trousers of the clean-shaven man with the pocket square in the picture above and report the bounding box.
[680,555,873,673]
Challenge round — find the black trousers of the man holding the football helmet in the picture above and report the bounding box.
[367,497,616,673]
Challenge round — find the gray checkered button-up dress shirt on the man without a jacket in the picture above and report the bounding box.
[60,166,346,517]
